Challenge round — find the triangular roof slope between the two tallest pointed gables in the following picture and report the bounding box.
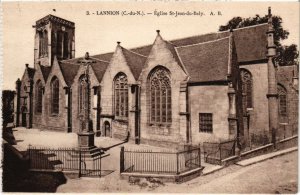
[121,47,147,79]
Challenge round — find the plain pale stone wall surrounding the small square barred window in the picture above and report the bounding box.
[189,85,229,145]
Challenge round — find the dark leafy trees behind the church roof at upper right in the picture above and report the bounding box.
[219,15,299,66]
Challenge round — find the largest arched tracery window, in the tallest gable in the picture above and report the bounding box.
[148,67,172,123]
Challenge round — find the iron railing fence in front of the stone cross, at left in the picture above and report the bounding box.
[28,146,101,177]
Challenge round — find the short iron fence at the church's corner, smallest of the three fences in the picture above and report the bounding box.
[203,140,236,165]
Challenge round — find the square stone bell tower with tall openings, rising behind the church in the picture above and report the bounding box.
[34,15,75,68]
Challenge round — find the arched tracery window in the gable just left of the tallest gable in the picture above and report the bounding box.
[114,73,128,118]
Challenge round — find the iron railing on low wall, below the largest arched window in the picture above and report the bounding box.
[120,147,201,175]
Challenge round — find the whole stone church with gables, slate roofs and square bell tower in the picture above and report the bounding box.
[14,7,298,147]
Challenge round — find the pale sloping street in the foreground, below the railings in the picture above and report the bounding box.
[57,151,298,193]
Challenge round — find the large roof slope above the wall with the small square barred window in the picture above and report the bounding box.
[176,37,231,82]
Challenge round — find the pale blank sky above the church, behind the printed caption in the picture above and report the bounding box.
[1,1,300,89]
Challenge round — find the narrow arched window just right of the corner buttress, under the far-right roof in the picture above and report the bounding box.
[240,69,253,113]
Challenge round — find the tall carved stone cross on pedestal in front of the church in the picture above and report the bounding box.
[78,52,95,149]
